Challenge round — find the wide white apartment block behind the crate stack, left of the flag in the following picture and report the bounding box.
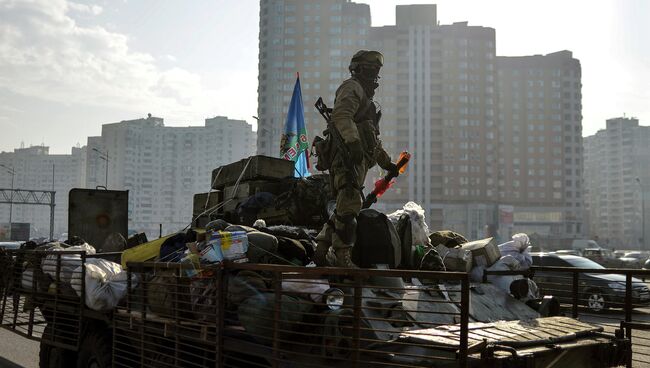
[87,116,256,237]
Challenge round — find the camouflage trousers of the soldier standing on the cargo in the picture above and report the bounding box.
[316,160,368,249]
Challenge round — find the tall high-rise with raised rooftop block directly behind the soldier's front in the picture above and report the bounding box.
[371,5,497,238]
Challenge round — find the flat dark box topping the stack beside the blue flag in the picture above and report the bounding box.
[212,155,295,189]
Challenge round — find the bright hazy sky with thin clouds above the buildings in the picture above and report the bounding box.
[0,0,650,153]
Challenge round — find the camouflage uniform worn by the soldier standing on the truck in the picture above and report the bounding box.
[316,49,395,267]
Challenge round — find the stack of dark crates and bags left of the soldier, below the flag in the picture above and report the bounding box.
[193,156,332,228]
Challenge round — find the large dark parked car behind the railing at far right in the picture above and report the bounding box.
[532,253,650,312]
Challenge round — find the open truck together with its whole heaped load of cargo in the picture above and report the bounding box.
[1,156,630,367]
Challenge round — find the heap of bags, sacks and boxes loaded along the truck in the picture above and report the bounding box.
[11,156,536,316]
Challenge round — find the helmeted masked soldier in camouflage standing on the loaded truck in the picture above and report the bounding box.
[315,50,397,268]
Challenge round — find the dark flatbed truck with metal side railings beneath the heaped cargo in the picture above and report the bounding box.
[0,158,631,368]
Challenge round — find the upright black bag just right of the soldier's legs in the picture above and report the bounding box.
[352,208,402,268]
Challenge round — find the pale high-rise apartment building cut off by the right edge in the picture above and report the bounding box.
[584,118,650,249]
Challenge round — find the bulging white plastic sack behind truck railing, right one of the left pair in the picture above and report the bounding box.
[70,258,137,311]
